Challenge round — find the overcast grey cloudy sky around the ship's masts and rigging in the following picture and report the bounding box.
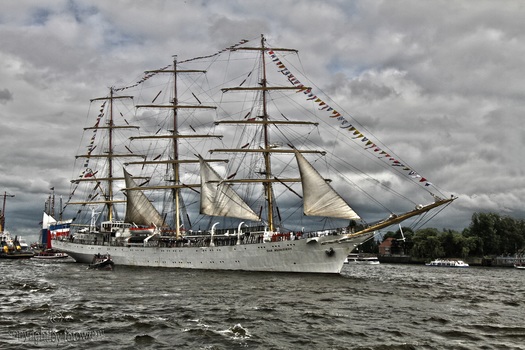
[0,0,525,242]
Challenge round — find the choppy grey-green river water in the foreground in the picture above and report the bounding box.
[0,260,525,350]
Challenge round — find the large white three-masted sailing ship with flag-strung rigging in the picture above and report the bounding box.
[53,35,456,274]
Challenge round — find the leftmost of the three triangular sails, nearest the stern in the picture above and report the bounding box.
[124,169,164,226]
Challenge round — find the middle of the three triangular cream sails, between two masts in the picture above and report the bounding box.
[200,158,261,221]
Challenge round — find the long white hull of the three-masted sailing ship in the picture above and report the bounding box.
[53,234,372,274]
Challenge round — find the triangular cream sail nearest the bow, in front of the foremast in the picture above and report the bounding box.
[295,150,359,219]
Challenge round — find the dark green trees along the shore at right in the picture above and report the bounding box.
[359,213,525,259]
